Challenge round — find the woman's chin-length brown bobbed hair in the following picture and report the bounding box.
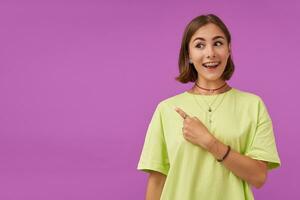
[175,14,234,83]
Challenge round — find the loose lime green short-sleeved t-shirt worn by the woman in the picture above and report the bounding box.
[137,88,280,200]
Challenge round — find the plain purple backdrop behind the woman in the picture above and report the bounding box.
[0,0,300,200]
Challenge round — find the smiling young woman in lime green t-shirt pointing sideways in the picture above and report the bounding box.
[138,14,280,200]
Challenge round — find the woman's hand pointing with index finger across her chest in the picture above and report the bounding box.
[175,107,214,150]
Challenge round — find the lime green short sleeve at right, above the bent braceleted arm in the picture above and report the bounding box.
[245,98,281,169]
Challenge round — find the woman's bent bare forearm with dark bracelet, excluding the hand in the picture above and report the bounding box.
[208,137,267,188]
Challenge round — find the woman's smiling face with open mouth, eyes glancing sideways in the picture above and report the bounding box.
[189,23,230,81]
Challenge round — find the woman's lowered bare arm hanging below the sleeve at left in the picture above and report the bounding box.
[146,171,166,200]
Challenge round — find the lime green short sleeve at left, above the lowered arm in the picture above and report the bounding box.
[137,104,170,175]
